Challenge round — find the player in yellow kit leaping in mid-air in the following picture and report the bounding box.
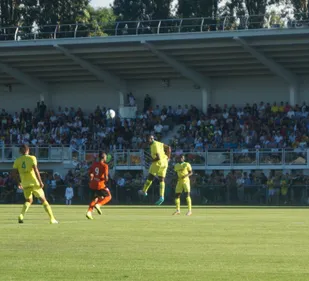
[139,135,171,205]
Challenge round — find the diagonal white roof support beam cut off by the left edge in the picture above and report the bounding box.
[0,62,48,93]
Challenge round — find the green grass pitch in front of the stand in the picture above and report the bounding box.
[0,205,309,281]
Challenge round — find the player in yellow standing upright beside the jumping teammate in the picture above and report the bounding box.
[173,155,193,216]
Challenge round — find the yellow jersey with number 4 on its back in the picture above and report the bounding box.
[13,155,40,188]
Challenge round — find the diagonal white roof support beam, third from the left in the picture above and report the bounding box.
[141,41,210,91]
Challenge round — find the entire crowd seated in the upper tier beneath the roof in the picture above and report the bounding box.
[0,97,309,156]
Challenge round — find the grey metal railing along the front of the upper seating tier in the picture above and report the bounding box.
[0,146,309,168]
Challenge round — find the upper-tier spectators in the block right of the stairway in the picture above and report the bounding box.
[172,102,309,151]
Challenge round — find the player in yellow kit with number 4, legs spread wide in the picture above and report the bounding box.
[13,145,58,224]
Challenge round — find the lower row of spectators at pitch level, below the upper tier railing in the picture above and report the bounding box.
[0,166,309,205]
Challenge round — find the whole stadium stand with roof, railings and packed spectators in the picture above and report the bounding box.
[0,13,309,204]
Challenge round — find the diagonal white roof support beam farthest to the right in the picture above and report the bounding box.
[233,37,299,85]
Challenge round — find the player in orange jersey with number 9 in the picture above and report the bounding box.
[86,152,112,220]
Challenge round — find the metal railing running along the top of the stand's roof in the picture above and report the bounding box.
[0,13,309,41]
